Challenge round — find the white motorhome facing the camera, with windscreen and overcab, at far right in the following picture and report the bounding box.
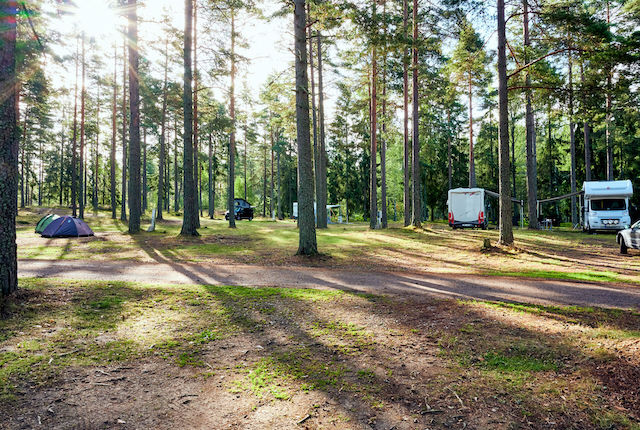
[582,179,633,231]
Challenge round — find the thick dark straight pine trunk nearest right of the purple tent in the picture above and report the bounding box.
[128,0,141,233]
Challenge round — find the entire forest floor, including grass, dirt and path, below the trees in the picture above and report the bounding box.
[7,207,640,430]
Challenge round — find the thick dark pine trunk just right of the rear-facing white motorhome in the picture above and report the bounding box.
[497,0,513,246]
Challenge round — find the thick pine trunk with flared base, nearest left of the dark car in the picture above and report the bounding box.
[180,0,199,236]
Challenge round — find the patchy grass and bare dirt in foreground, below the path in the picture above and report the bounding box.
[0,278,640,429]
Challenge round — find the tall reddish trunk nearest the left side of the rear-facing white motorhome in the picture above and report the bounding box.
[411,0,422,227]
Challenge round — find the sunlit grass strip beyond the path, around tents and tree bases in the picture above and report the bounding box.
[18,210,640,283]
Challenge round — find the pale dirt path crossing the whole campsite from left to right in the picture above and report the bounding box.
[18,260,640,309]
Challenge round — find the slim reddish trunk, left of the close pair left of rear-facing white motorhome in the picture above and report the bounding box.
[402,0,412,227]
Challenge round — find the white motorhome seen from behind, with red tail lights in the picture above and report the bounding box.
[447,188,487,229]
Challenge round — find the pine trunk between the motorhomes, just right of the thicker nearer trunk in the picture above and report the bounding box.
[522,0,538,229]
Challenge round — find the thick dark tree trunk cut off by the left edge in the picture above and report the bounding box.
[0,1,19,298]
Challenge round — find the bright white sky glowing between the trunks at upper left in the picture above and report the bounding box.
[45,0,293,122]
